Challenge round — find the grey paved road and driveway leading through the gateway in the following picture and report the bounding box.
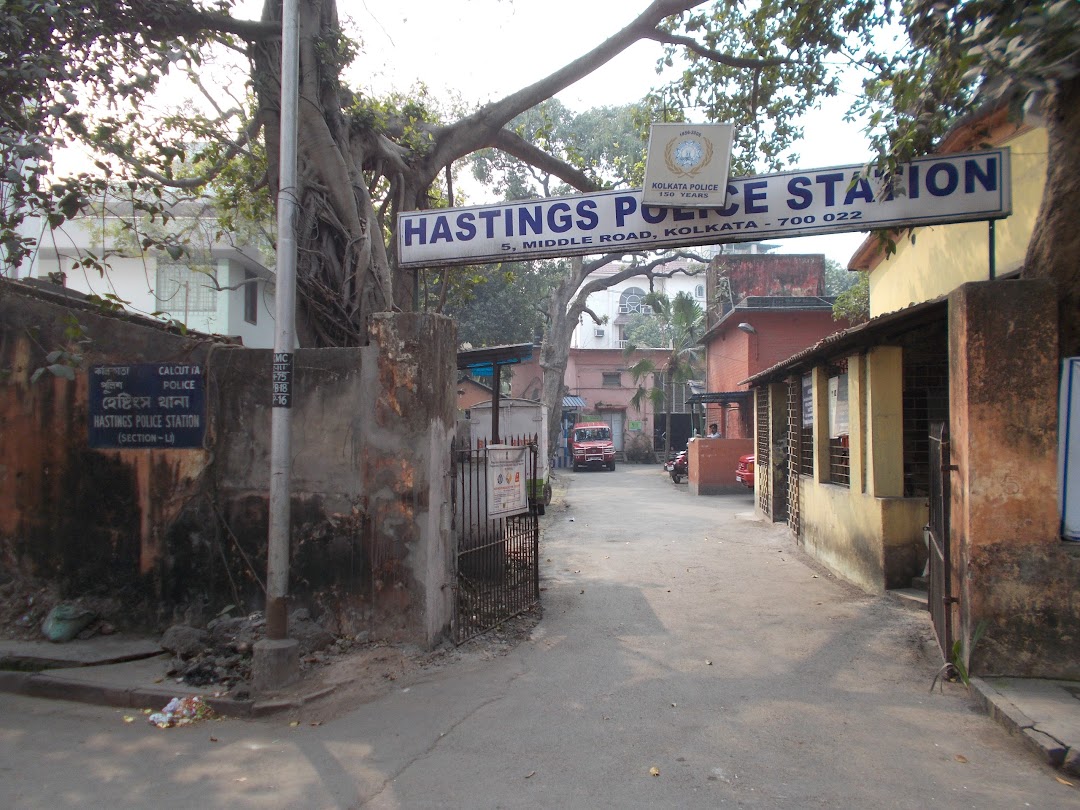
[0,465,1080,810]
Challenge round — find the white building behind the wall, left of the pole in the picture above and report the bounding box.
[8,206,275,349]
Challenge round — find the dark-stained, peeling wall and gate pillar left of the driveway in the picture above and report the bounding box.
[0,283,456,643]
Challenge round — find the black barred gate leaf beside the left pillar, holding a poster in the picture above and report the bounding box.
[453,436,540,644]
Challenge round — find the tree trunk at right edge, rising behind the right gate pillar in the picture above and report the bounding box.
[1024,79,1080,357]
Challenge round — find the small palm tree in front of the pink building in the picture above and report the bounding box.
[623,293,705,458]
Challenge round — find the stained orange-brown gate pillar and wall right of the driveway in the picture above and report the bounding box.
[949,281,1080,678]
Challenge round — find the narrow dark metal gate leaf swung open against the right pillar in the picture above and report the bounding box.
[927,422,957,661]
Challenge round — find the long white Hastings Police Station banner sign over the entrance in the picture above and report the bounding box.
[397,149,1012,268]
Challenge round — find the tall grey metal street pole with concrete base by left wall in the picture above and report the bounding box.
[252,0,299,690]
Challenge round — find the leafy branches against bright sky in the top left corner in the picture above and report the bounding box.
[0,0,231,273]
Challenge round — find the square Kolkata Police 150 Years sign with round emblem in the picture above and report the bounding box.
[642,124,733,208]
